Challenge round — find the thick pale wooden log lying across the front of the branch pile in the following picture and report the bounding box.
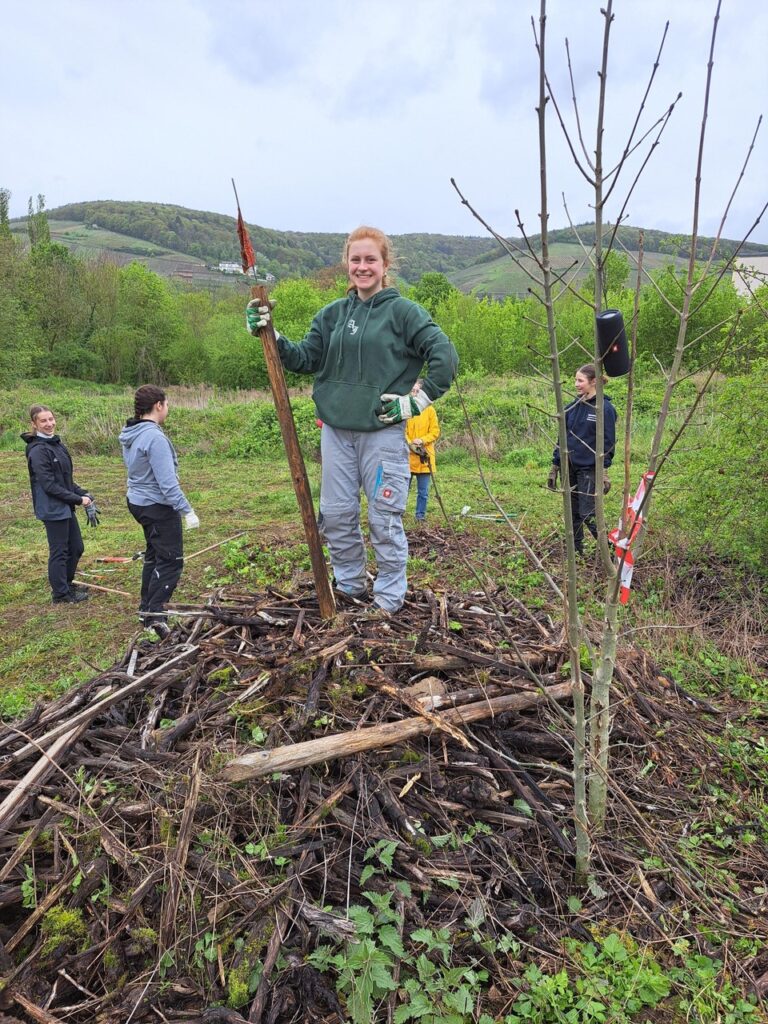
[220,683,572,782]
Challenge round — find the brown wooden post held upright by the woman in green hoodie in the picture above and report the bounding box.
[251,285,336,618]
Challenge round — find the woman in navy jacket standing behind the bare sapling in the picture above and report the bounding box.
[547,362,616,555]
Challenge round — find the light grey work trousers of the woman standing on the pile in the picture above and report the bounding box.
[321,423,411,611]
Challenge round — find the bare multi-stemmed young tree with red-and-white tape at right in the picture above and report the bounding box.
[457,0,768,882]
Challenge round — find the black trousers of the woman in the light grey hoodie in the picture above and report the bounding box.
[128,502,184,612]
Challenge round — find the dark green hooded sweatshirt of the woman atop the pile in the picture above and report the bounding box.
[278,288,459,431]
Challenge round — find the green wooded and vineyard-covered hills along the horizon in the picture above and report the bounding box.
[11,201,765,297]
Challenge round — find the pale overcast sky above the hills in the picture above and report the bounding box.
[0,0,768,243]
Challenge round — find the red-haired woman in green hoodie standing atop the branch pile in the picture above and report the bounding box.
[246,227,459,613]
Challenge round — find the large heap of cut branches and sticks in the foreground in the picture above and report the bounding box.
[0,589,768,1024]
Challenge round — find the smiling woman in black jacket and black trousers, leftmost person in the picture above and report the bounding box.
[22,406,93,604]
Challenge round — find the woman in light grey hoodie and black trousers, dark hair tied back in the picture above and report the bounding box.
[120,384,200,636]
